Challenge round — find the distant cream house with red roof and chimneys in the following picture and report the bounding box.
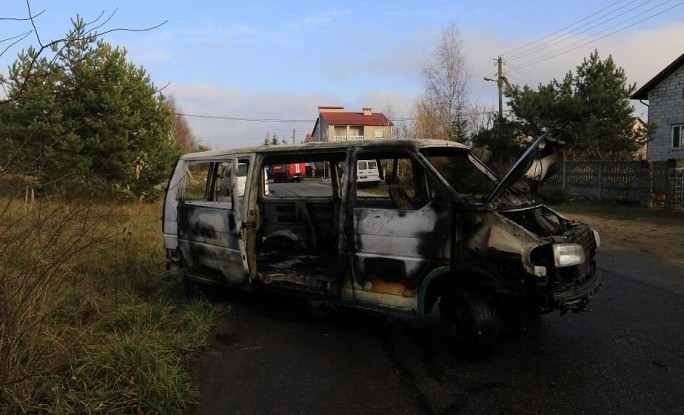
[309,107,393,141]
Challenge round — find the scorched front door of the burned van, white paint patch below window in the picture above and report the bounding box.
[350,151,452,309]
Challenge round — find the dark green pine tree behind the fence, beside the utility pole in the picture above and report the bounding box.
[509,51,652,160]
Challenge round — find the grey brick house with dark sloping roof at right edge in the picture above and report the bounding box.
[630,54,684,164]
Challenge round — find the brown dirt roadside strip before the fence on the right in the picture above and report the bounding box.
[564,214,684,273]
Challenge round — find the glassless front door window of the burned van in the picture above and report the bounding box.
[354,153,428,210]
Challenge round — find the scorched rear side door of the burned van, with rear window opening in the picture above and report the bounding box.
[178,158,247,285]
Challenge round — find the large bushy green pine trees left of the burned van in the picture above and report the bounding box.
[0,16,198,198]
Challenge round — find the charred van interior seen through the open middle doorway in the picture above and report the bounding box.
[256,152,345,296]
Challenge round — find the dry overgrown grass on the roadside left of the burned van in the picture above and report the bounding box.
[0,197,220,414]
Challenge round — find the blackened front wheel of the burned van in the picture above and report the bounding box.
[439,291,498,358]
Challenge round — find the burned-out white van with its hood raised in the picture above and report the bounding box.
[163,132,602,354]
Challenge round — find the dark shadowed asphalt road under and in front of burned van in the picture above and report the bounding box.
[194,245,684,414]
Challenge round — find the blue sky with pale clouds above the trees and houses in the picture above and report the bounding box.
[0,0,684,148]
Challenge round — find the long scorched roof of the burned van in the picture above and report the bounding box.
[176,138,469,160]
